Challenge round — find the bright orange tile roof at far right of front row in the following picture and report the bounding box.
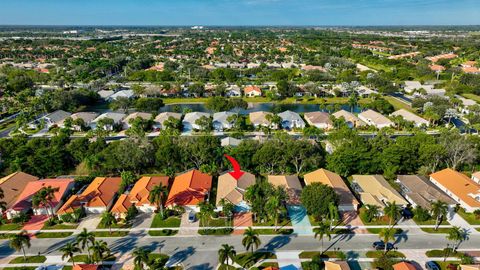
[430,168,480,208]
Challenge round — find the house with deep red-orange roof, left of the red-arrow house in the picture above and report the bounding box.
[165,170,212,210]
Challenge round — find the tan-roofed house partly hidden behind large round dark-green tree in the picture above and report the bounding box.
[303,169,359,211]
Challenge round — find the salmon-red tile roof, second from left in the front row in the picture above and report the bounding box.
[11,178,74,211]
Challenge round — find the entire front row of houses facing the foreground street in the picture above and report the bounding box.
[0,169,480,224]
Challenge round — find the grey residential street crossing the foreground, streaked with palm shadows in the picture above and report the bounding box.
[0,232,480,269]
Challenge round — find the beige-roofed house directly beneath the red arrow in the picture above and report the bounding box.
[216,172,255,206]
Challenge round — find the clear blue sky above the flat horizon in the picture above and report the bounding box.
[0,0,480,25]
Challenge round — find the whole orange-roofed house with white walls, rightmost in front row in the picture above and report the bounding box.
[430,168,480,213]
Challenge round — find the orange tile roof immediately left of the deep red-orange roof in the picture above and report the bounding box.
[111,176,168,213]
